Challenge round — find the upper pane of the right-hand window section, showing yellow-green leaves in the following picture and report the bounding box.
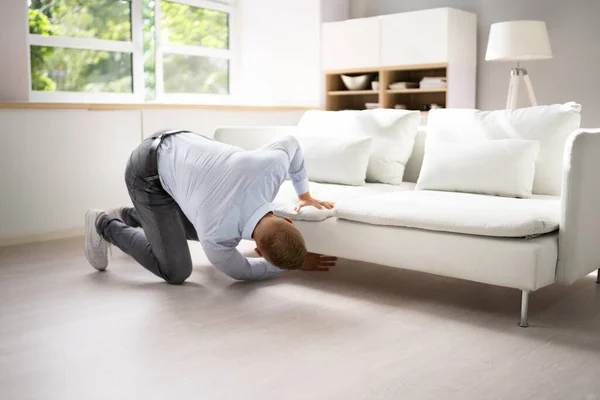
[160,1,229,49]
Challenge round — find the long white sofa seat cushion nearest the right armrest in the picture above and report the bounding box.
[335,191,560,238]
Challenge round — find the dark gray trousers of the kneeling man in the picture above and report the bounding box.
[96,139,198,284]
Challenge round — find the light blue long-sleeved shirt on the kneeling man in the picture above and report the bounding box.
[158,133,308,280]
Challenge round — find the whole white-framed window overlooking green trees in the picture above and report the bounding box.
[29,0,233,102]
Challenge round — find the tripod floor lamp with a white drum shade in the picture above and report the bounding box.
[485,21,552,109]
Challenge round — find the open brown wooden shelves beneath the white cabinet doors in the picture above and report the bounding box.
[325,64,448,111]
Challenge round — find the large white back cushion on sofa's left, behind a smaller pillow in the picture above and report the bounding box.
[298,109,420,185]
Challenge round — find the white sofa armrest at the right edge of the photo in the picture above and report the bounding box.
[556,129,600,284]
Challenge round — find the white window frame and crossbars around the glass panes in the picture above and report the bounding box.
[27,0,238,104]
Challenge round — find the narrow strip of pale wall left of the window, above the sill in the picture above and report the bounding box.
[0,0,29,101]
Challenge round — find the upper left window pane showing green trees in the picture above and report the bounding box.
[29,0,131,41]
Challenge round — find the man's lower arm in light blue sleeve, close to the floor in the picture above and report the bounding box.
[201,241,283,281]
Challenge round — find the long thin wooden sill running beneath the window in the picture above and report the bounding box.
[0,101,318,111]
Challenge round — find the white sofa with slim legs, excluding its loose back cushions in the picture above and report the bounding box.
[215,114,600,327]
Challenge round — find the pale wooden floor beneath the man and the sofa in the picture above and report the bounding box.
[0,239,600,400]
